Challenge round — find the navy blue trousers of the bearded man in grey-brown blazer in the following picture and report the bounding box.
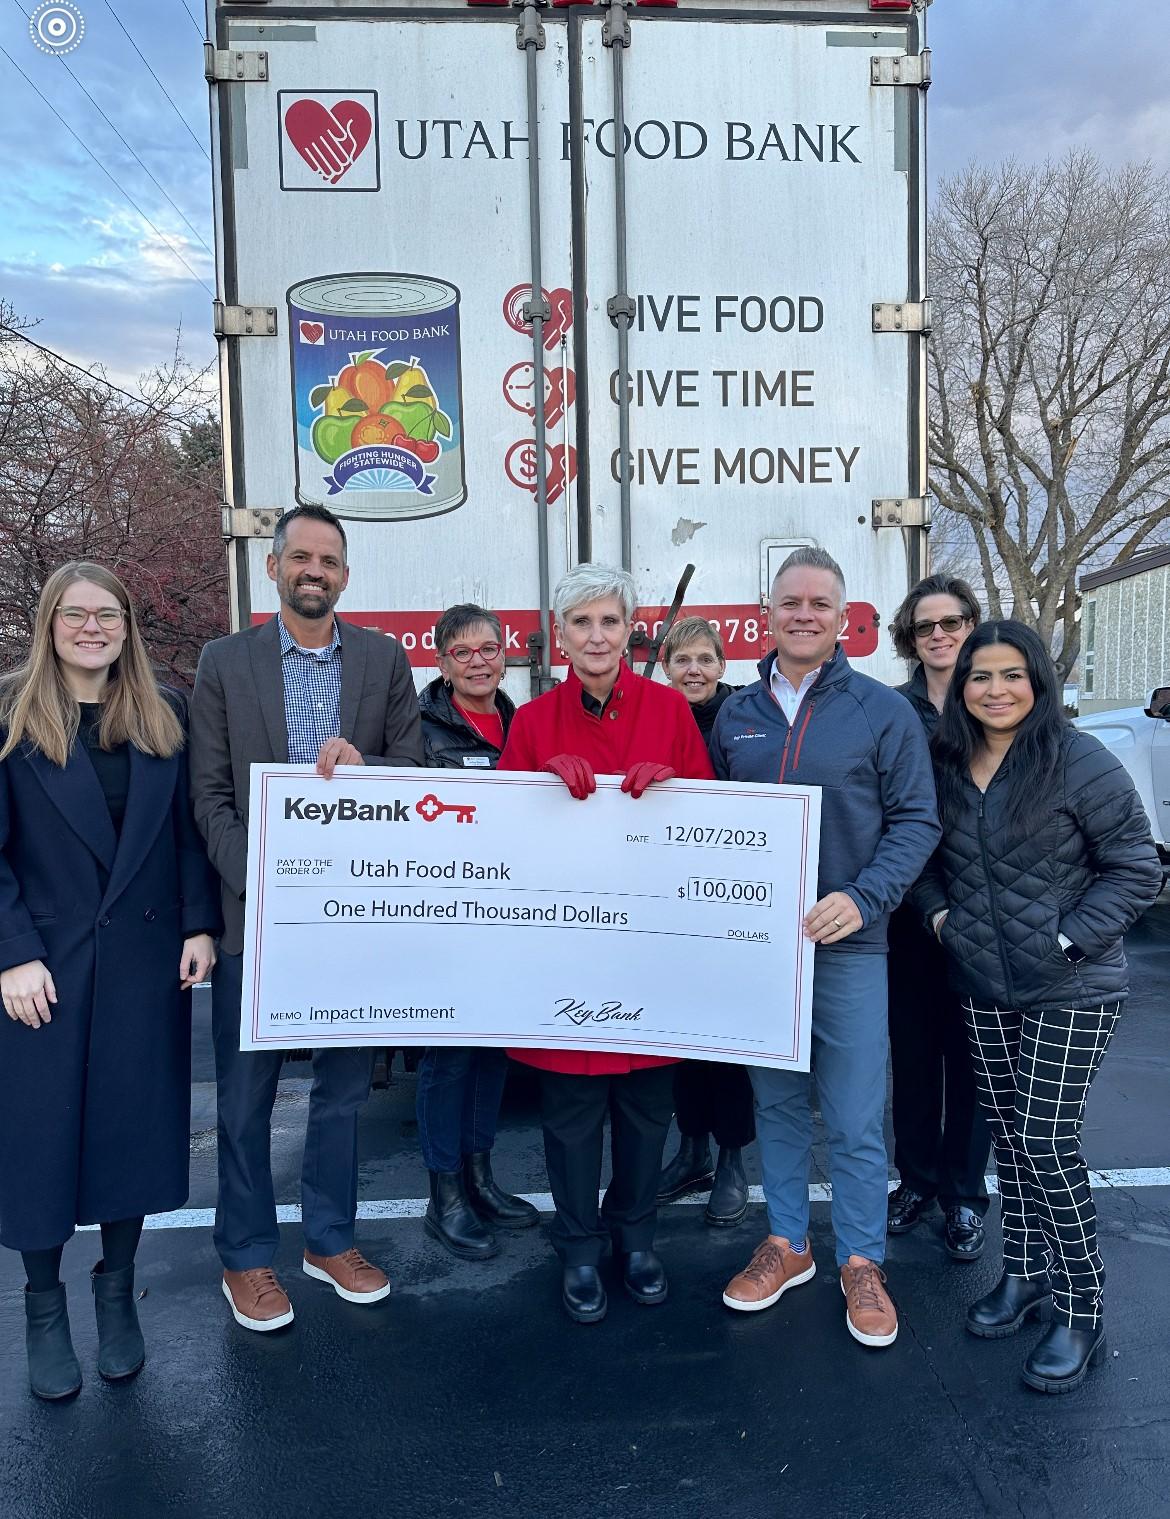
[211,954,374,1271]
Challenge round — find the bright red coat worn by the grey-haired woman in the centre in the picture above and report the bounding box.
[497,664,714,1075]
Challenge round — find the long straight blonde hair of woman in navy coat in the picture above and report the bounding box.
[0,561,184,767]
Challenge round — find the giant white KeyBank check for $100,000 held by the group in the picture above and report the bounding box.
[240,766,821,1069]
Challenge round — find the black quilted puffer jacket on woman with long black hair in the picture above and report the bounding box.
[913,728,1162,1007]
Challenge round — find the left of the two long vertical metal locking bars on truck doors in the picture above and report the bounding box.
[514,0,553,696]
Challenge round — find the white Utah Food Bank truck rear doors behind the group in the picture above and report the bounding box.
[207,0,930,697]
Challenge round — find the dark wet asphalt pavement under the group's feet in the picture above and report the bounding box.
[0,905,1170,1519]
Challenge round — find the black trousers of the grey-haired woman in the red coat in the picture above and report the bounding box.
[541,1065,673,1265]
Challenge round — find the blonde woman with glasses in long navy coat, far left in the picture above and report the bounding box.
[0,564,219,1399]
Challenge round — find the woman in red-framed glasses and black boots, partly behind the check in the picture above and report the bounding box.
[418,603,539,1261]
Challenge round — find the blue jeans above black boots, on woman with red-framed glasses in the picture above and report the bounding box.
[415,1048,508,1171]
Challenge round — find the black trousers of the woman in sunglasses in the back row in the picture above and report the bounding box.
[889,907,991,1215]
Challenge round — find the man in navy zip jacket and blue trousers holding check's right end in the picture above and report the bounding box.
[711,548,939,1347]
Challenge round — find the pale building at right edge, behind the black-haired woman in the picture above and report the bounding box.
[1080,548,1170,712]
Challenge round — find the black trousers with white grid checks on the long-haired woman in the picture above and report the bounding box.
[965,1003,1121,1329]
